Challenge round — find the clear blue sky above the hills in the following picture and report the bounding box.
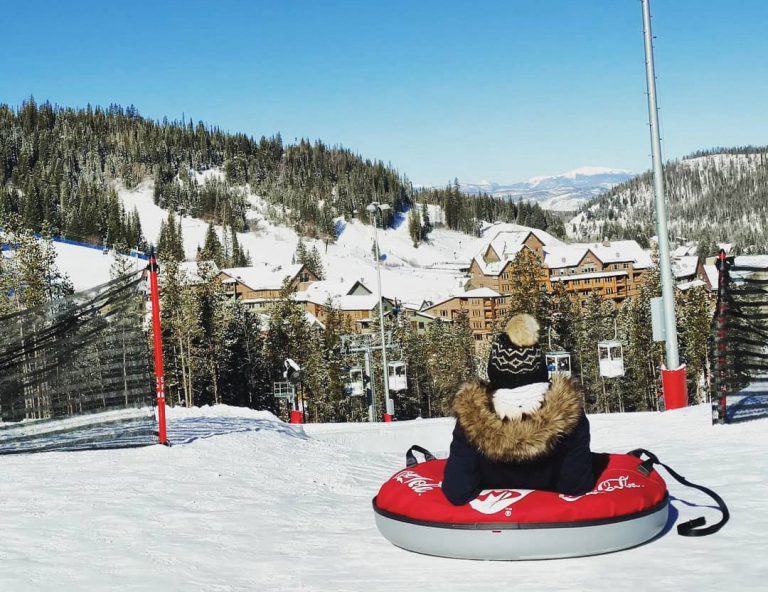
[0,0,768,184]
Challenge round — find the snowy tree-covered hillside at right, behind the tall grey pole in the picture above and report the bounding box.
[567,147,768,255]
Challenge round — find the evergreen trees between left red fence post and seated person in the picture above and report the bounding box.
[161,260,474,422]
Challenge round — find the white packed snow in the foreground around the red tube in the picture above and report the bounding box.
[0,406,768,592]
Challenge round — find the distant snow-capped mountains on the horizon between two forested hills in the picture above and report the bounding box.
[461,166,634,212]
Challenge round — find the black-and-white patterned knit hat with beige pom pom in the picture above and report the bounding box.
[488,314,549,389]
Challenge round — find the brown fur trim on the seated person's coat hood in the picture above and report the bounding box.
[453,374,583,462]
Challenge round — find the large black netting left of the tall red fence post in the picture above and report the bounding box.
[0,272,157,454]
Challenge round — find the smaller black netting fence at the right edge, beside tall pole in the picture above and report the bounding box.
[711,253,768,423]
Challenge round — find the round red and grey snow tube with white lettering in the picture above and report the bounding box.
[373,454,669,560]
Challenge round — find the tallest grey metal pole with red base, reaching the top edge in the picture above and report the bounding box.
[640,0,688,409]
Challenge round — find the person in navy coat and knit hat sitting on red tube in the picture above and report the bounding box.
[442,314,594,505]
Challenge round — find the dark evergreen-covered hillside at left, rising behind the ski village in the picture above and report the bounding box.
[0,99,562,246]
